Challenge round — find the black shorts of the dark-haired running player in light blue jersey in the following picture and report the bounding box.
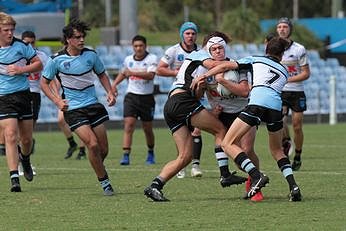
[64,103,109,131]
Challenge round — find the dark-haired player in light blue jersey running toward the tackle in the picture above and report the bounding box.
[41,20,115,196]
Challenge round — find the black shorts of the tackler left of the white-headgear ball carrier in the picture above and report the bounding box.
[164,92,204,133]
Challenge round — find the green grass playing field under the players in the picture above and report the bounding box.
[0,124,346,231]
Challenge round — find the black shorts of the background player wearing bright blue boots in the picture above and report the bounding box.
[124,93,155,121]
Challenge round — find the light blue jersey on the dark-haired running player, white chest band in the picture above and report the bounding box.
[42,48,105,110]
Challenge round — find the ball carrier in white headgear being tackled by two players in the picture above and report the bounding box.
[198,31,263,201]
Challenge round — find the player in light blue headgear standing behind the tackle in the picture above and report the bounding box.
[156,22,202,178]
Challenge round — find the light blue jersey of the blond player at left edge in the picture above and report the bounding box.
[0,38,36,95]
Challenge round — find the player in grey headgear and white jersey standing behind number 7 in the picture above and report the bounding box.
[276,18,310,171]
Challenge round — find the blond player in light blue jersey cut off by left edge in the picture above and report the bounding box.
[0,12,42,192]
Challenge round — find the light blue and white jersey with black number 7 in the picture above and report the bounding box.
[237,56,288,111]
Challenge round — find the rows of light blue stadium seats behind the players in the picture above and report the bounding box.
[38,43,346,123]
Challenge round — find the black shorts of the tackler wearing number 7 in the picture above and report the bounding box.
[239,105,283,132]
